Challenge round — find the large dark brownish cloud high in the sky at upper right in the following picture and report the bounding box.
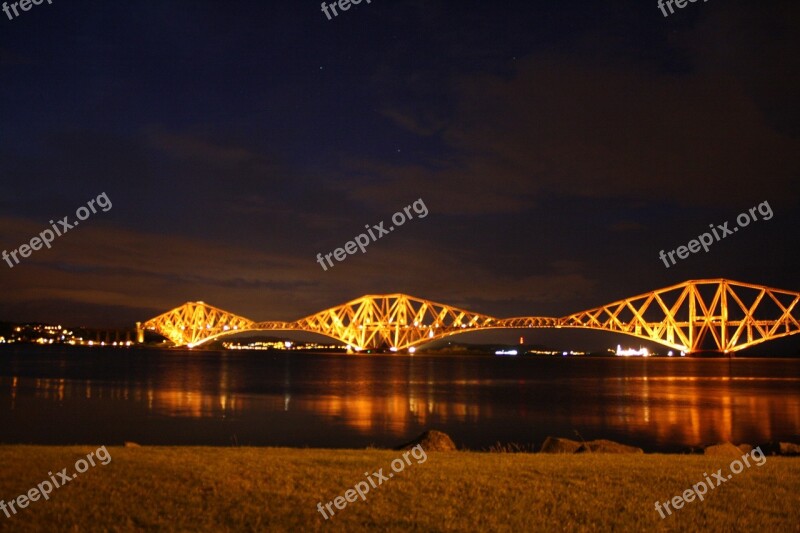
[352,54,800,214]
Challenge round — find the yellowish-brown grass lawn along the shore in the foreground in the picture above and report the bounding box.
[0,445,800,533]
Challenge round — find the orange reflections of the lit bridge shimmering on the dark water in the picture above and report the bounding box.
[0,356,800,447]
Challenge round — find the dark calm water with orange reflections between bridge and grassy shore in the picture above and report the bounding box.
[0,347,800,451]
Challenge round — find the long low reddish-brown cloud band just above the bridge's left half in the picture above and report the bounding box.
[0,209,594,325]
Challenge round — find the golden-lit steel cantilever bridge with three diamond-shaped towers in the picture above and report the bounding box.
[137,279,800,354]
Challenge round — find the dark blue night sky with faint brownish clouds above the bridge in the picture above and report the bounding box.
[0,0,800,348]
